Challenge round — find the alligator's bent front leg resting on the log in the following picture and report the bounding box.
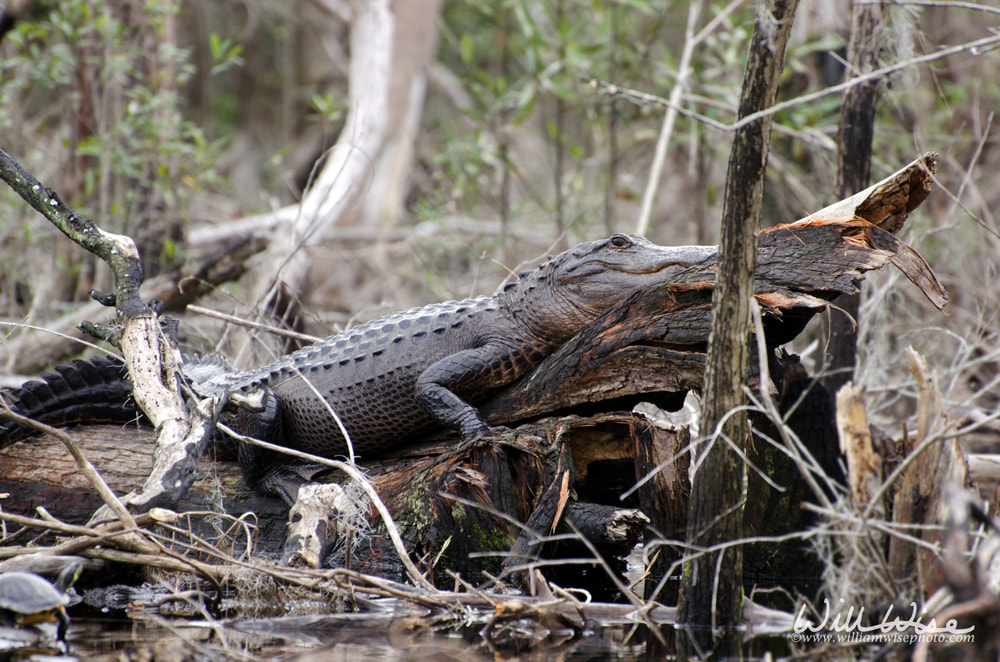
[415,345,531,441]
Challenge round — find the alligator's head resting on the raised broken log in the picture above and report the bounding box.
[504,234,717,342]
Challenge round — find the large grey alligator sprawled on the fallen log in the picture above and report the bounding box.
[0,234,716,504]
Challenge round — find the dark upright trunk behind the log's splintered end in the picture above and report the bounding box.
[823,4,882,394]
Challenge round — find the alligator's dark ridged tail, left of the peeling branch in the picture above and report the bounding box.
[0,357,141,448]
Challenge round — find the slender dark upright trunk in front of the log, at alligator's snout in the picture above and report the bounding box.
[679,0,798,658]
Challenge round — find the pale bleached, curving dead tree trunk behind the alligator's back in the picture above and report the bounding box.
[238,0,439,364]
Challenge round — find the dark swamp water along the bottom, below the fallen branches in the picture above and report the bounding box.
[0,598,804,662]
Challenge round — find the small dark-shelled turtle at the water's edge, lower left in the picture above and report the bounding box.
[0,561,83,642]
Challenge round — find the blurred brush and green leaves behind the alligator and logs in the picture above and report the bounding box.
[0,0,1000,430]
